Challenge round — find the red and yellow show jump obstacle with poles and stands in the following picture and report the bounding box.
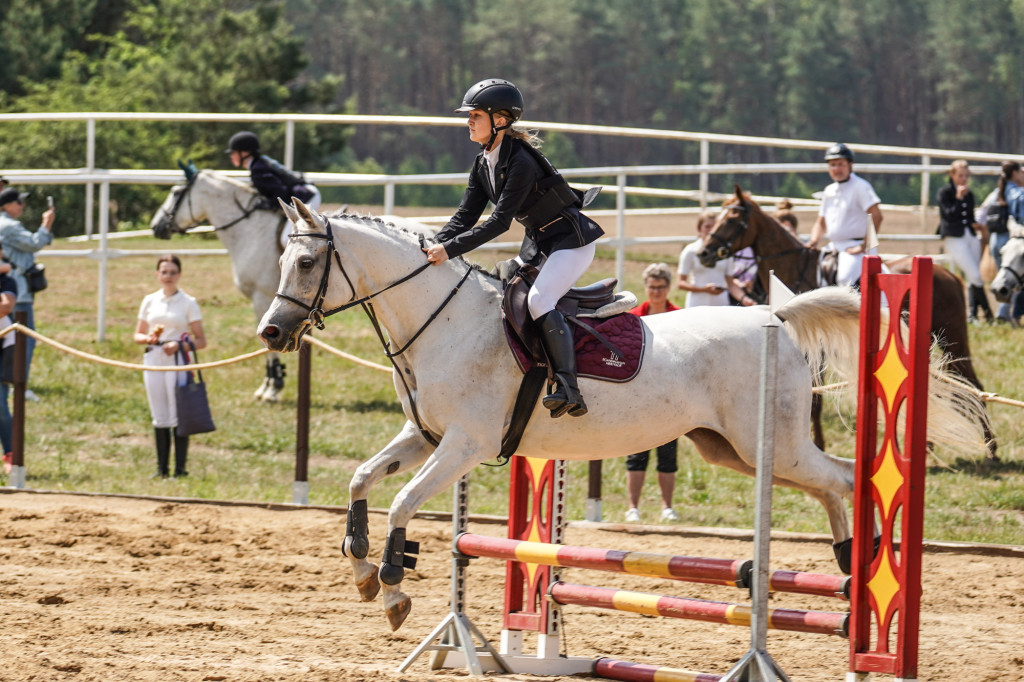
[398,257,932,682]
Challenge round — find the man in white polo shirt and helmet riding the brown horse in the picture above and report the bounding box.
[807,142,882,287]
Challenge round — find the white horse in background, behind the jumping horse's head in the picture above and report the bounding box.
[150,162,434,402]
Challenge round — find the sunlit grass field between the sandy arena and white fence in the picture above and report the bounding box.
[14,220,1024,544]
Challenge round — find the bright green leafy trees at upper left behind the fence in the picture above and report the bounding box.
[0,0,346,235]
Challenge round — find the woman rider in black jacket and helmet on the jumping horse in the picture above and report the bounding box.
[424,78,604,417]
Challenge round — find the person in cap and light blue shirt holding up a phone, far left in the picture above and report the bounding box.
[0,187,56,400]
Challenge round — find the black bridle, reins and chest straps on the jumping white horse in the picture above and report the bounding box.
[275,216,473,447]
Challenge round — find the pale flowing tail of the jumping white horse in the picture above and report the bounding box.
[778,287,990,455]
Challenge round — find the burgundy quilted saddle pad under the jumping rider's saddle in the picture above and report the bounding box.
[503,312,644,382]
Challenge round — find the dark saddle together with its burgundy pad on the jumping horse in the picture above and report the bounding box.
[502,265,644,382]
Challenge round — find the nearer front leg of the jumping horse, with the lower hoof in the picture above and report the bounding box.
[380,427,491,630]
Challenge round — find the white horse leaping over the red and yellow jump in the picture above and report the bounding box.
[253,196,984,629]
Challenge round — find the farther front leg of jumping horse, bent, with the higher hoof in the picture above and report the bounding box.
[341,422,433,601]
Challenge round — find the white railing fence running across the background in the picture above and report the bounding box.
[0,112,1011,340]
